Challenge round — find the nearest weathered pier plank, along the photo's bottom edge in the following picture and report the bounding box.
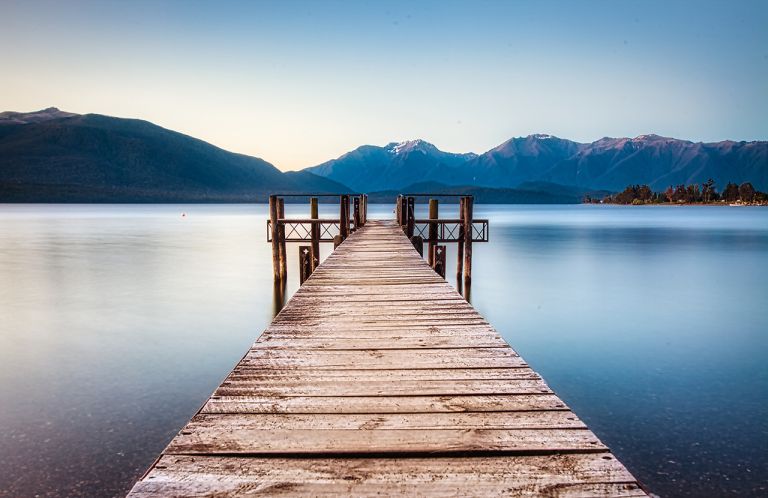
[132,454,645,498]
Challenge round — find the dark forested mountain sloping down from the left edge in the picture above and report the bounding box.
[0,108,349,202]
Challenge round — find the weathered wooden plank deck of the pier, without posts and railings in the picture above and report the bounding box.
[129,220,647,498]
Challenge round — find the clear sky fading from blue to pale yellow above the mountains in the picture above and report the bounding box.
[0,0,768,169]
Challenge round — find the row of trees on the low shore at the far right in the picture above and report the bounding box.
[583,179,768,206]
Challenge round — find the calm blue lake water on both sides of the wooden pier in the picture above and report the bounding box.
[0,205,768,497]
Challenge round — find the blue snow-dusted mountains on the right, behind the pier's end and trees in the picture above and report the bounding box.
[305,134,768,191]
